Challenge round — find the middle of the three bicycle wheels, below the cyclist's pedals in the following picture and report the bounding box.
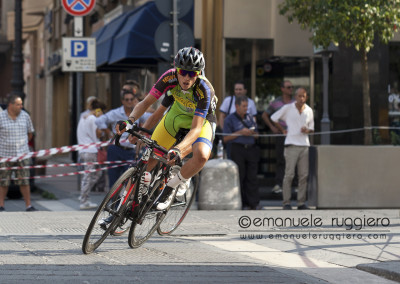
[128,180,165,248]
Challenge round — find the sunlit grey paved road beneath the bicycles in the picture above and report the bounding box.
[0,156,400,284]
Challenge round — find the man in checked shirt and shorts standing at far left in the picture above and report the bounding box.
[0,95,37,211]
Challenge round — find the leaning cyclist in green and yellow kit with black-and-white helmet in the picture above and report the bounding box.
[116,47,217,210]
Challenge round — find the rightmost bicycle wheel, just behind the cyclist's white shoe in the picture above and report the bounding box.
[157,175,199,235]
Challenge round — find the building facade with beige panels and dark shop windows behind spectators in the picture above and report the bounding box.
[0,0,400,164]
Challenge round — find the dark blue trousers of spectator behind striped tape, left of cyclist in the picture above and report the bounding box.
[107,145,135,188]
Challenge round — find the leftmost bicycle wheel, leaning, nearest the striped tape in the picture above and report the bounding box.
[82,167,136,254]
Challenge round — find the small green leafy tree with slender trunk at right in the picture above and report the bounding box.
[279,0,400,144]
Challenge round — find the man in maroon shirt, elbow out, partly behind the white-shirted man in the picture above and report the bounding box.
[262,80,294,193]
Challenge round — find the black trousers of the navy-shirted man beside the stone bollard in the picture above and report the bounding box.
[231,143,260,208]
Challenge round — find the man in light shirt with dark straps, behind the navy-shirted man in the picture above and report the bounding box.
[219,81,257,159]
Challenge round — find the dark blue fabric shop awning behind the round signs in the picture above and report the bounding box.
[92,1,193,72]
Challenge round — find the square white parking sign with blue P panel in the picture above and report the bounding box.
[62,37,96,72]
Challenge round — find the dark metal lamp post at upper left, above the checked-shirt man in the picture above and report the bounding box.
[11,0,25,100]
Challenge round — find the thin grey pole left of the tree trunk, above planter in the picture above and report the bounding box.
[321,52,331,145]
